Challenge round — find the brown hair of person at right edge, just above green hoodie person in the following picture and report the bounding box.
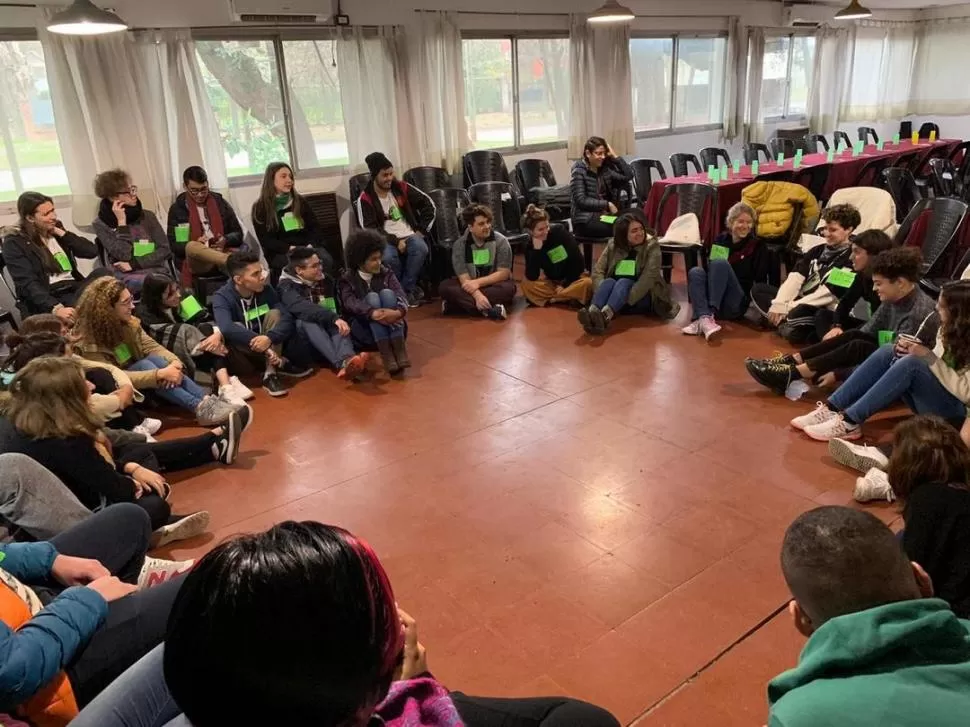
[887,416,970,509]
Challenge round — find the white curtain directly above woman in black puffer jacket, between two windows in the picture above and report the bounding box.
[567,15,635,158]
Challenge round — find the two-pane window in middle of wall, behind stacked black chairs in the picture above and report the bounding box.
[462,38,570,149]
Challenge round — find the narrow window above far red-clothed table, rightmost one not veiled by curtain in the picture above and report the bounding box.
[761,35,815,119]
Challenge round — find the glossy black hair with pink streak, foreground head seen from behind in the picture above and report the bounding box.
[164,522,404,727]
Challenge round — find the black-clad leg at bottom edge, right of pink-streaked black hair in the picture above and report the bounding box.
[451,692,620,727]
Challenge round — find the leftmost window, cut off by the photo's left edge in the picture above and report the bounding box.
[0,40,71,202]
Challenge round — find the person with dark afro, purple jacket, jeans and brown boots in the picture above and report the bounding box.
[338,230,411,376]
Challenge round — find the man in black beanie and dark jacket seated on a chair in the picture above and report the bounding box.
[357,151,435,308]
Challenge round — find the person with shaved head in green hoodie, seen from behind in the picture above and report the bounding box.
[768,507,970,727]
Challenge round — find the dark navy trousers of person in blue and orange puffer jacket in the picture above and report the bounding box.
[42,503,182,707]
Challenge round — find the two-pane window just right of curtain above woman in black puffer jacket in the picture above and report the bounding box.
[630,36,727,131]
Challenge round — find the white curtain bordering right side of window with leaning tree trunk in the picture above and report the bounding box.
[334,26,398,170]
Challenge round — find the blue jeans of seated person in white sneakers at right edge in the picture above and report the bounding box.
[829,346,967,424]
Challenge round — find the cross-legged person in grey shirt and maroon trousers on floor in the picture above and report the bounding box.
[438,204,515,321]
